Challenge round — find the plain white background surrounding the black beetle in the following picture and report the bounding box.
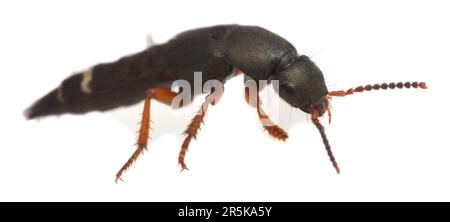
[0,0,450,201]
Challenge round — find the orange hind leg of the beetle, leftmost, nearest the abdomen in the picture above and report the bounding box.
[116,88,183,183]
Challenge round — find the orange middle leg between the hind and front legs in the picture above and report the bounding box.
[178,91,223,171]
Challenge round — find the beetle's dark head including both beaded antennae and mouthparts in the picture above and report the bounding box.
[274,55,427,173]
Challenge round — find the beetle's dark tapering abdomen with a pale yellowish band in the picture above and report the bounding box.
[25,45,165,119]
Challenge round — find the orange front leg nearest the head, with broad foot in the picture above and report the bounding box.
[245,87,289,141]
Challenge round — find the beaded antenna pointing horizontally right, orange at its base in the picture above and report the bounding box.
[328,82,428,96]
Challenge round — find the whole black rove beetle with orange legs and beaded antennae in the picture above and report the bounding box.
[25,25,427,182]
